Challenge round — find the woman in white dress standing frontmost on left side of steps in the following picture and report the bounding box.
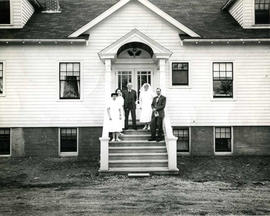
[107,93,122,141]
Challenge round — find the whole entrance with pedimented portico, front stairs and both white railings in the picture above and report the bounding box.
[99,29,178,172]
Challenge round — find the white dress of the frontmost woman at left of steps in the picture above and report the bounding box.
[106,99,123,132]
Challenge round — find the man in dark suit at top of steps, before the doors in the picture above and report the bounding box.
[123,83,137,130]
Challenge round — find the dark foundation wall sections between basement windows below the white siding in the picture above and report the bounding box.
[4,126,270,160]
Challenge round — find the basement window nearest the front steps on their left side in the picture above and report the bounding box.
[60,128,78,155]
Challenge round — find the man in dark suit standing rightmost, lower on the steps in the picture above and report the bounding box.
[149,88,166,142]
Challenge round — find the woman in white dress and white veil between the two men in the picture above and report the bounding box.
[140,83,154,130]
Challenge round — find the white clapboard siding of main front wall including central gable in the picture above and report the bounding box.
[0,1,270,127]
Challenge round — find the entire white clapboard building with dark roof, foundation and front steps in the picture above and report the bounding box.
[0,0,270,172]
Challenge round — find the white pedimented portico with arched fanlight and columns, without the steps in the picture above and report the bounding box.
[98,29,172,103]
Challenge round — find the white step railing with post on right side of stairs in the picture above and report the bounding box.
[163,114,179,171]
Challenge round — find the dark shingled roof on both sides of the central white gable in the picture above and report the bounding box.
[0,0,270,39]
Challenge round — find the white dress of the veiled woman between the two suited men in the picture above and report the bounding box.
[140,90,154,123]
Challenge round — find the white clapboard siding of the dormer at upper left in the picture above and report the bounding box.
[0,0,34,29]
